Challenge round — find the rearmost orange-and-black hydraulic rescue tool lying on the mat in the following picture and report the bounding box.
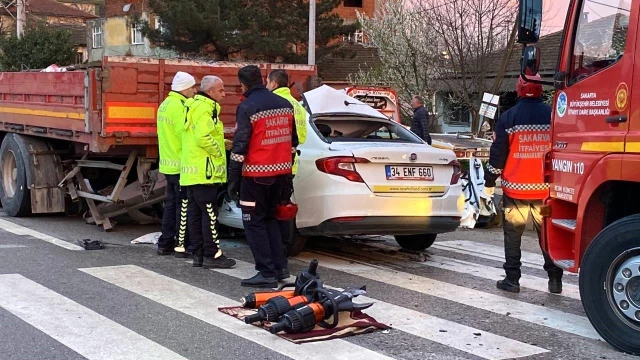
[240,259,322,309]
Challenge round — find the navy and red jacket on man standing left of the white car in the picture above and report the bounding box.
[228,85,298,182]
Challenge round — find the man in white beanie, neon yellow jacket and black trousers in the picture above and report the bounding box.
[157,71,196,258]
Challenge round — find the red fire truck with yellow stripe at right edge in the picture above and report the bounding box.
[518,0,640,355]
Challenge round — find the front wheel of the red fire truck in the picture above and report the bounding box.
[580,214,640,355]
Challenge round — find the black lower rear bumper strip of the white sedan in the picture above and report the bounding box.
[299,216,460,236]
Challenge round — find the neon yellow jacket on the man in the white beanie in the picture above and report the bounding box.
[157,91,187,175]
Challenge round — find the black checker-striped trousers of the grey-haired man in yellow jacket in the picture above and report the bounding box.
[187,185,222,258]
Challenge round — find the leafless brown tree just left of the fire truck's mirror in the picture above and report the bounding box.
[412,0,517,131]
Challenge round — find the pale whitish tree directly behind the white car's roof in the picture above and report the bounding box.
[350,0,442,123]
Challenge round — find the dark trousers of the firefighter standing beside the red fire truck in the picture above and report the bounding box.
[502,195,562,282]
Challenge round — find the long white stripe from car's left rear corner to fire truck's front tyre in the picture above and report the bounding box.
[296,253,600,339]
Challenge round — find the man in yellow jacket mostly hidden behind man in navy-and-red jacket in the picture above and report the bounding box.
[267,70,307,262]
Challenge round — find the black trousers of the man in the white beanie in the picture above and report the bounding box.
[158,175,189,250]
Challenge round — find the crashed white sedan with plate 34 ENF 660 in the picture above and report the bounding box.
[218,86,465,255]
